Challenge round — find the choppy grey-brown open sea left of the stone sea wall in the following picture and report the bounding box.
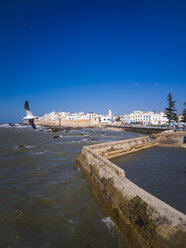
[0,125,140,248]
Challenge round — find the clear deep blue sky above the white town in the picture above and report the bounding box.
[0,0,186,122]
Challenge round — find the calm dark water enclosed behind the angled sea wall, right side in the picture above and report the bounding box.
[112,147,186,214]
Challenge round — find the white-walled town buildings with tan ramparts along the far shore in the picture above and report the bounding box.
[33,109,177,126]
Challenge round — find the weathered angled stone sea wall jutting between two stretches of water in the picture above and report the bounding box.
[76,134,186,248]
